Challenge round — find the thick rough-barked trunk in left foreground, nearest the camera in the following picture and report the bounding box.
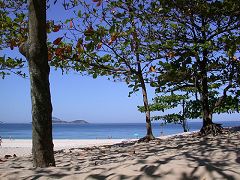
[27,0,55,167]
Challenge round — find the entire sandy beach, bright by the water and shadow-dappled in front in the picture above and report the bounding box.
[0,131,240,180]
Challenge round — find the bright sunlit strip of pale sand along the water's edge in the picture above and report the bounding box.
[0,129,236,159]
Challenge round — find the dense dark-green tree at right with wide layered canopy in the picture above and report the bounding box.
[139,0,240,134]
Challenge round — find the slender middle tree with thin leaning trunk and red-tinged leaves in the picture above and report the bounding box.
[49,1,162,139]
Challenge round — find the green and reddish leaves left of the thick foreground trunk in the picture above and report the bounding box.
[0,0,27,78]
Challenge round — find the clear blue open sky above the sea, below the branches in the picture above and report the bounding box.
[0,0,239,123]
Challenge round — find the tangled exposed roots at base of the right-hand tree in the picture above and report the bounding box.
[200,123,223,136]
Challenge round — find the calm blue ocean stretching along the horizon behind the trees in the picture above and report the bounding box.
[0,121,240,139]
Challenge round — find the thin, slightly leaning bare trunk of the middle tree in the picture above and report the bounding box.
[139,75,155,141]
